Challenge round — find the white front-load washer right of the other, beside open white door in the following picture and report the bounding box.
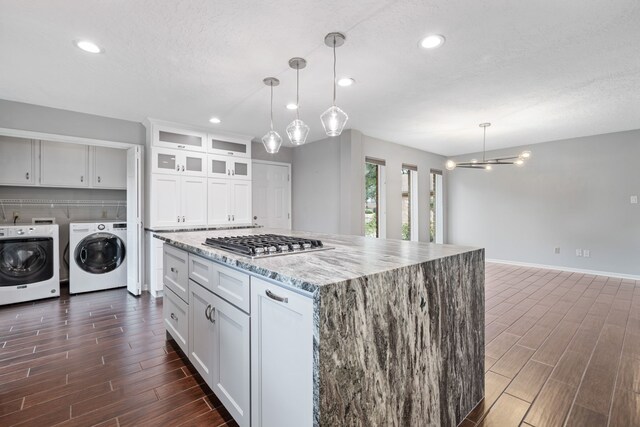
[69,222,127,294]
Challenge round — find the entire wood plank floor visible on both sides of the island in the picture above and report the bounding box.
[0,264,640,427]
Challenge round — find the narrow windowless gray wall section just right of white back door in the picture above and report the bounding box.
[291,138,341,233]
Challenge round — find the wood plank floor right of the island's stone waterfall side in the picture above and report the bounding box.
[463,264,640,427]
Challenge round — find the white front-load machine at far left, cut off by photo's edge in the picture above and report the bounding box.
[0,224,60,305]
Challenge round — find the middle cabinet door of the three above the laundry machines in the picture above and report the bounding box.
[40,141,89,187]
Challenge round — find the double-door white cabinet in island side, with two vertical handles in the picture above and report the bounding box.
[188,281,251,427]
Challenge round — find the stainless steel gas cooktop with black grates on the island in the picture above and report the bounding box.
[204,234,333,258]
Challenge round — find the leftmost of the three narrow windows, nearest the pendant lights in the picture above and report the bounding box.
[364,158,386,237]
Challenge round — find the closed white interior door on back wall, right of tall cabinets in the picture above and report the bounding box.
[252,161,291,229]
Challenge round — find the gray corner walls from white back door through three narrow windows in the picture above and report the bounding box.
[293,130,446,242]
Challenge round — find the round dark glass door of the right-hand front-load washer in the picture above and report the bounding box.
[73,233,125,274]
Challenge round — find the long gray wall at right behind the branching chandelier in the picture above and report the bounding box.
[447,130,640,275]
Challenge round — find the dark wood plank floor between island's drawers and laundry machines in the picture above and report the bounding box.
[0,289,237,426]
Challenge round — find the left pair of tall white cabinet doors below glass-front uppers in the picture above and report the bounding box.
[150,174,207,227]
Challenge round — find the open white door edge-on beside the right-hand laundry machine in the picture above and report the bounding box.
[127,147,143,295]
